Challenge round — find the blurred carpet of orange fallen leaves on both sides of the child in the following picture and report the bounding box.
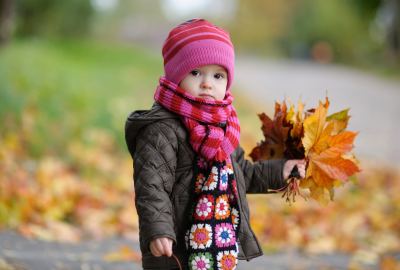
[0,121,400,264]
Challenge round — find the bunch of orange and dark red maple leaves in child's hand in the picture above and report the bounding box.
[250,98,360,203]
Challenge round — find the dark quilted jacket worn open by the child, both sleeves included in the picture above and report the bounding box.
[125,104,284,269]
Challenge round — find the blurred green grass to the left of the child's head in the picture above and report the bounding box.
[0,40,162,156]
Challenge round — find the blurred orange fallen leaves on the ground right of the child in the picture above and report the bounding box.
[248,164,400,264]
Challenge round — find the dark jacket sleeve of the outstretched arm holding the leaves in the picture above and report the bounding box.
[234,146,286,193]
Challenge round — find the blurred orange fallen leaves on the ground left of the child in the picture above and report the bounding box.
[0,127,138,242]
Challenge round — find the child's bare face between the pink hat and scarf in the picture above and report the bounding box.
[179,65,228,100]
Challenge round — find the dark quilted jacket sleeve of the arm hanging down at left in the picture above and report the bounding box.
[133,122,177,250]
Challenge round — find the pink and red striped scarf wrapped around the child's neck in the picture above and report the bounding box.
[154,77,240,162]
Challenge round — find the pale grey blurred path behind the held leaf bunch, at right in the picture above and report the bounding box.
[235,57,400,166]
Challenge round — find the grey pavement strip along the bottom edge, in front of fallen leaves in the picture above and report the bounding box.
[0,231,377,270]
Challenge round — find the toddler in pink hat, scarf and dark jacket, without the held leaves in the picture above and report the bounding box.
[125,19,305,270]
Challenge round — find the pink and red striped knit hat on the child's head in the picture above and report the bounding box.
[162,19,235,90]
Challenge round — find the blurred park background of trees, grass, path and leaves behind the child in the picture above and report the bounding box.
[0,0,400,269]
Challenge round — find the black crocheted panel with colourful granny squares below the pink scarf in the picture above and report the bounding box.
[185,161,240,270]
